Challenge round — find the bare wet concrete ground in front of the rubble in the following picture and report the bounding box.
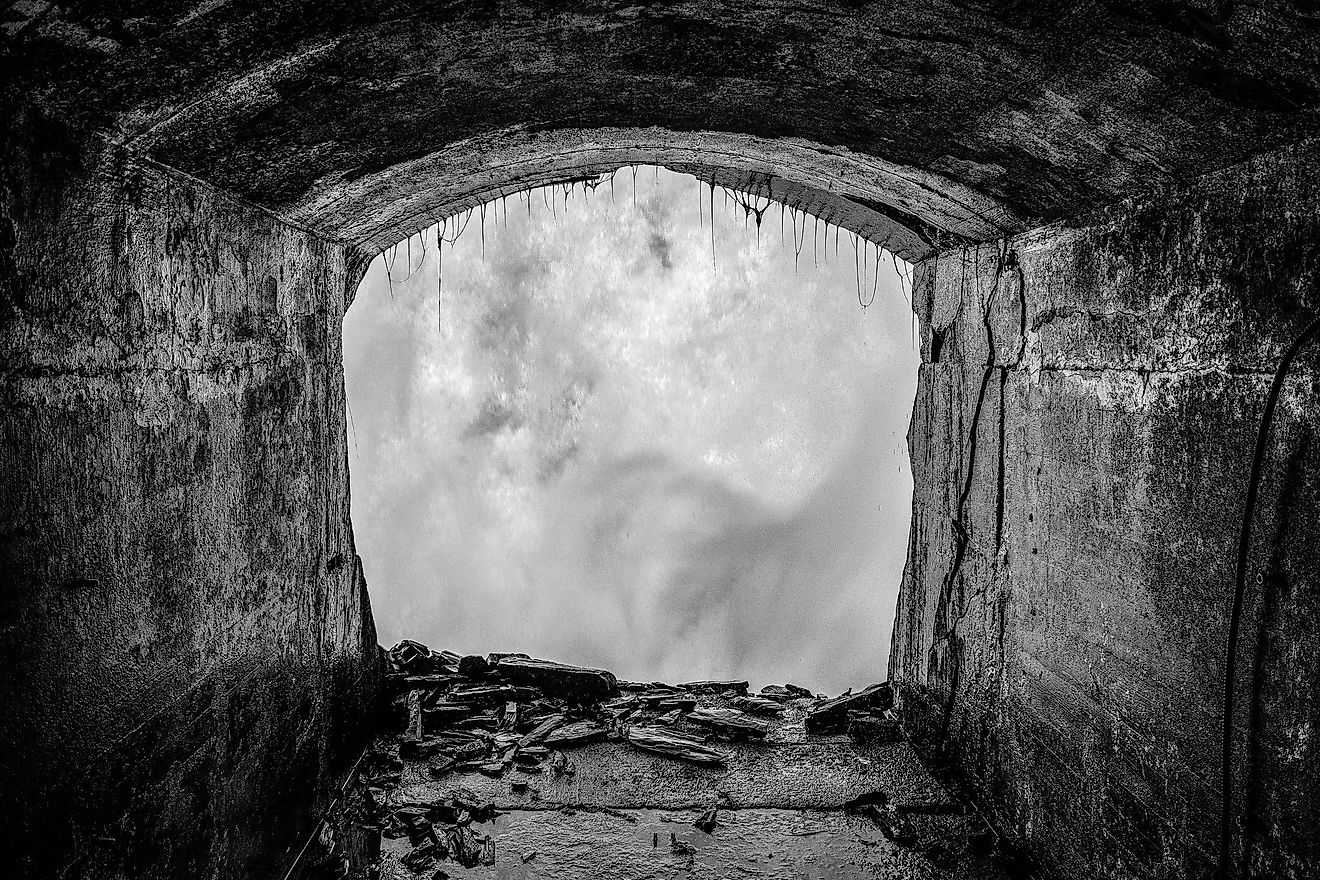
[317,680,1028,880]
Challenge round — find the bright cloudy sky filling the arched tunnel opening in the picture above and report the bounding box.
[343,165,920,693]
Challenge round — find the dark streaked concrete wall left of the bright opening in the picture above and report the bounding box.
[0,125,376,879]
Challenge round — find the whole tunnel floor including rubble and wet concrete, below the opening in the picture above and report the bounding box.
[303,643,1024,880]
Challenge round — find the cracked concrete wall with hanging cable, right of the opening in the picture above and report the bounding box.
[891,141,1320,877]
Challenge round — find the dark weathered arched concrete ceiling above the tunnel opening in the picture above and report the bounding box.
[0,0,1320,256]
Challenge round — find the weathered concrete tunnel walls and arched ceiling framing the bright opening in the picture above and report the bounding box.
[0,0,1320,877]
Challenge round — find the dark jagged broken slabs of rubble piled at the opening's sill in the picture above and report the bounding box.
[358,641,902,877]
